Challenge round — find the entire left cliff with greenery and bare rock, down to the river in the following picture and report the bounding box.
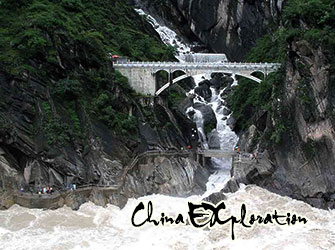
[0,1,208,208]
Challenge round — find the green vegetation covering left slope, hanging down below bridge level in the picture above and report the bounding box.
[0,0,174,145]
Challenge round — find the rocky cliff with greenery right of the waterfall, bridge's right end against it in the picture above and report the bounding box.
[223,1,335,209]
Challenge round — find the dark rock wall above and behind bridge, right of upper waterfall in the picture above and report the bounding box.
[139,0,284,61]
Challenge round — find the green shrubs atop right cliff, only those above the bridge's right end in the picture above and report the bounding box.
[247,0,335,62]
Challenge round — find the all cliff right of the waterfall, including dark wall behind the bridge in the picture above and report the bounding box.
[141,0,335,208]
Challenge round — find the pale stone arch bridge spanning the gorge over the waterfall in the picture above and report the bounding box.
[113,61,280,96]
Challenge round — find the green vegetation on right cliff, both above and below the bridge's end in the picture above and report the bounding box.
[229,0,335,144]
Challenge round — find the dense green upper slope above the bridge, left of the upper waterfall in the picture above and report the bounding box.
[0,0,173,75]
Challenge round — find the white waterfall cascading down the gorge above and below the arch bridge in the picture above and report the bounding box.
[135,9,237,192]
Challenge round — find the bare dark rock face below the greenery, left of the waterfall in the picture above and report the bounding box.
[0,73,208,209]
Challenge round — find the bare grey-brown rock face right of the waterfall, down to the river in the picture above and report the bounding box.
[227,40,335,208]
